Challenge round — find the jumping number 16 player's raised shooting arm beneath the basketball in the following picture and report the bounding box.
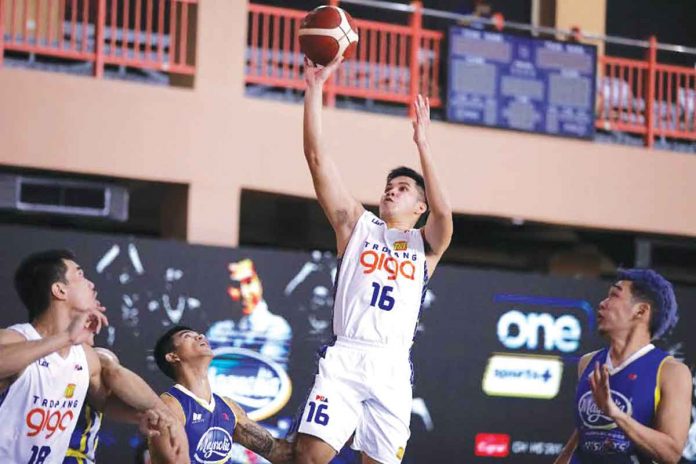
[303,57,364,255]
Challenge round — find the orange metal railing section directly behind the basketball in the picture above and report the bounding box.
[245,1,443,115]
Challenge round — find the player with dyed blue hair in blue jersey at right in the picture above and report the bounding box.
[556,269,691,464]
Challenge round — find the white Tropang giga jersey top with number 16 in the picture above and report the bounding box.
[333,211,427,348]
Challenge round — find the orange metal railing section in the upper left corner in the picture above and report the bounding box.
[0,0,198,77]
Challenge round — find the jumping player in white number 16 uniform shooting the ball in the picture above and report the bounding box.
[295,59,453,464]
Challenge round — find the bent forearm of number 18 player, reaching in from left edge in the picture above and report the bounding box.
[0,333,71,379]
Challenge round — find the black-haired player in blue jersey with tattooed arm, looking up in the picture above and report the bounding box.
[150,326,293,464]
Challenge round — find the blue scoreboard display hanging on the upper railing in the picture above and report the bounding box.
[447,27,597,138]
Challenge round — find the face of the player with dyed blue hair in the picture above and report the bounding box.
[597,280,638,334]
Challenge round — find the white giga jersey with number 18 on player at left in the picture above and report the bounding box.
[0,324,89,464]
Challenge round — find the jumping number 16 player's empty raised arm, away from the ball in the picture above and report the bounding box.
[413,95,454,275]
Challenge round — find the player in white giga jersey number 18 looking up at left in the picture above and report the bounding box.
[0,250,185,464]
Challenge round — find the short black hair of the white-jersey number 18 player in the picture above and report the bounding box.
[14,250,75,322]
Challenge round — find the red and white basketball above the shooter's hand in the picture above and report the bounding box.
[299,6,358,66]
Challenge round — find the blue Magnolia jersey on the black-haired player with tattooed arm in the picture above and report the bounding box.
[164,384,237,464]
